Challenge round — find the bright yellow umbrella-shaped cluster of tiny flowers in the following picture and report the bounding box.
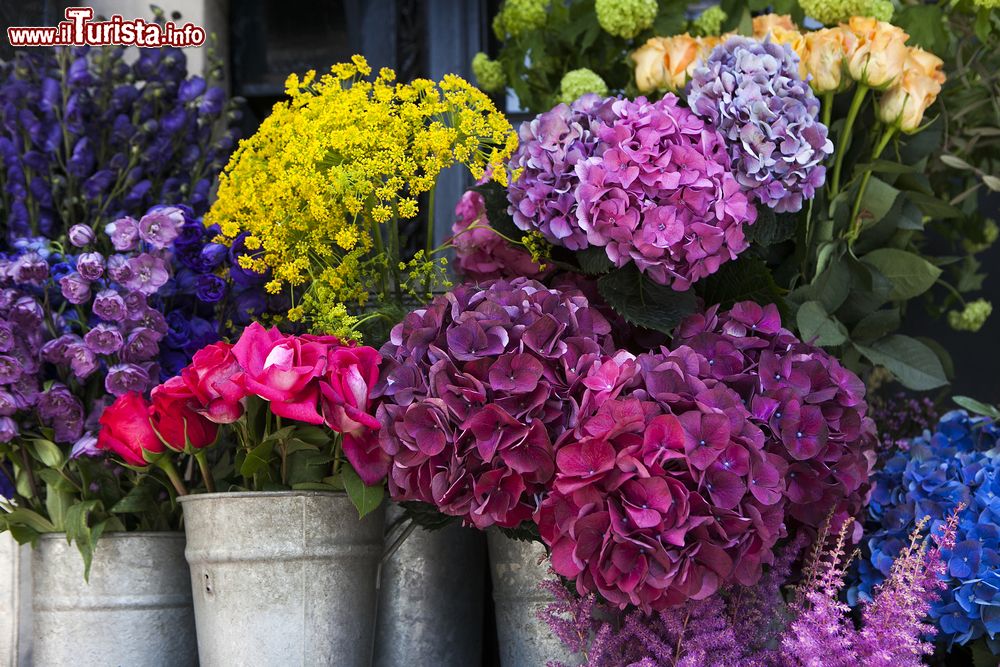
[205,56,517,328]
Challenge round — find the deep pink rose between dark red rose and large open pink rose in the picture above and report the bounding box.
[181,343,246,424]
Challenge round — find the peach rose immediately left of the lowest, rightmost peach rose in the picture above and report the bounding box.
[847,16,909,89]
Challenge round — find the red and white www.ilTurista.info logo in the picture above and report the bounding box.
[7,7,205,48]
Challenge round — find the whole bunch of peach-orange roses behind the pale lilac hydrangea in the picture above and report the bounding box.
[631,14,945,132]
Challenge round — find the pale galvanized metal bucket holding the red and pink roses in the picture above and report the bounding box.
[181,491,384,667]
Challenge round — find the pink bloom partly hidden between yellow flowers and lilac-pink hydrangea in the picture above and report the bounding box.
[451,190,549,281]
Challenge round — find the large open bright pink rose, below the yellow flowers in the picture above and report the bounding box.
[233,322,329,424]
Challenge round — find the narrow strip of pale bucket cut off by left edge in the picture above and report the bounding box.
[0,533,31,667]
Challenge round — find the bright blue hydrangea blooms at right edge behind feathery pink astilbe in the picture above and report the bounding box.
[851,410,1000,653]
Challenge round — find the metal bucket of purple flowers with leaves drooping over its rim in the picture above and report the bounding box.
[31,533,198,667]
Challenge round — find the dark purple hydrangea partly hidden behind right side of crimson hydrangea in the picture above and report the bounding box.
[675,301,877,539]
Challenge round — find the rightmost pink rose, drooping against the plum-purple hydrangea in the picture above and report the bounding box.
[320,347,389,484]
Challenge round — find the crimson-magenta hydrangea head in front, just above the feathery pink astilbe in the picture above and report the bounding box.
[536,346,786,611]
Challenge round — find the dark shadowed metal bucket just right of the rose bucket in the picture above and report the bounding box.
[375,505,486,667]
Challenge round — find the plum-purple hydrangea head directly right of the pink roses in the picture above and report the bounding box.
[373,277,611,528]
